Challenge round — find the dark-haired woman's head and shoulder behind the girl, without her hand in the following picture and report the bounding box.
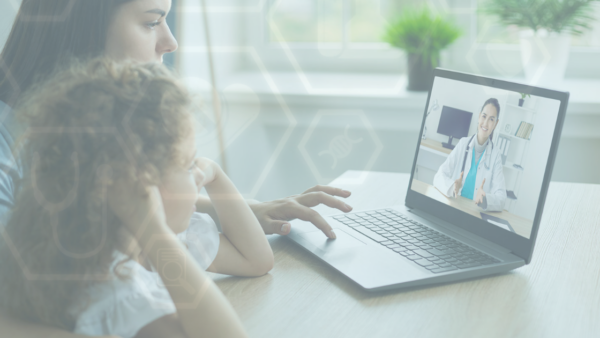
[0,0,177,220]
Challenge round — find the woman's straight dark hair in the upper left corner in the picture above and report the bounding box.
[0,0,131,106]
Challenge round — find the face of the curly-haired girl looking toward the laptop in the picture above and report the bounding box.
[158,135,204,233]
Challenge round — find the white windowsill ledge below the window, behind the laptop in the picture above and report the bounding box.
[214,72,600,115]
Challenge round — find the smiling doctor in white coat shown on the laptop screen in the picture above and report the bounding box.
[433,98,506,211]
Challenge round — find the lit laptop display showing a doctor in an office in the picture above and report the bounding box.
[411,77,561,239]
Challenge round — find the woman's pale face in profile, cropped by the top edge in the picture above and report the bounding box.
[106,0,177,62]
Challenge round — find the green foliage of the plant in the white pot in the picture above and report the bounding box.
[482,0,599,35]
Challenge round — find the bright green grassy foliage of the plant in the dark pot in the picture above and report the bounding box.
[383,7,461,67]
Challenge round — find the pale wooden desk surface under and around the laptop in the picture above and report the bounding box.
[214,172,600,338]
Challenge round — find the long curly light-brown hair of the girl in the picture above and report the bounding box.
[0,59,193,330]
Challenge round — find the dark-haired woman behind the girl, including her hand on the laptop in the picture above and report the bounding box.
[0,0,352,337]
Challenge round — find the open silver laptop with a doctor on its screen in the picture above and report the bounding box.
[288,68,569,291]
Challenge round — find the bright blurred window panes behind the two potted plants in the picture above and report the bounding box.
[245,0,600,78]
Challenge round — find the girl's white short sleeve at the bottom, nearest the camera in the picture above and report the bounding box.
[71,253,177,338]
